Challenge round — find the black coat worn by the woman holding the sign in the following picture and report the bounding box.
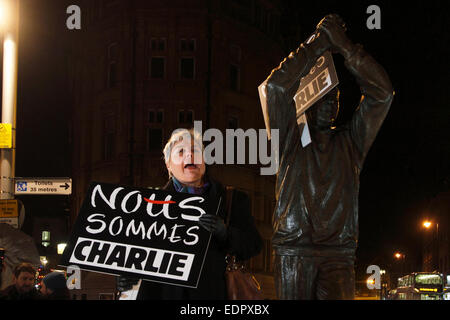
[137,176,262,300]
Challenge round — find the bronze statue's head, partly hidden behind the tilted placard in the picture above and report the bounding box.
[306,87,340,130]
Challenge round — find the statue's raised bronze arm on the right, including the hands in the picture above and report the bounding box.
[318,15,394,164]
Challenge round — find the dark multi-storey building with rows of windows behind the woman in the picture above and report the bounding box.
[69,0,285,299]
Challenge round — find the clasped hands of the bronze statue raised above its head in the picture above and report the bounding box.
[317,14,354,58]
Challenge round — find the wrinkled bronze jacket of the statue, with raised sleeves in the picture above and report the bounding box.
[266,42,393,255]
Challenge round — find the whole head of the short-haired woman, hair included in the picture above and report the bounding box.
[163,129,206,188]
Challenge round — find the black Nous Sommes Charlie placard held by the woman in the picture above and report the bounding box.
[60,183,215,288]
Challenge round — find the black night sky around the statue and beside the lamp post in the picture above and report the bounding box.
[7,0,450,284]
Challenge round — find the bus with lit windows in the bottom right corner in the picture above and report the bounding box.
[395,272,444,300]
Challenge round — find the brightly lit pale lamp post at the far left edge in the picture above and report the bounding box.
[0,0,19,199]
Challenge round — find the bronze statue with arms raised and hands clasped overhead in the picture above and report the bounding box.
[266,15,393,299]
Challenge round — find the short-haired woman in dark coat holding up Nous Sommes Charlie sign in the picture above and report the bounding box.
[117,129,262,300]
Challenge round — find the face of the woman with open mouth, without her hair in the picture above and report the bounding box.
[166,140,206,186]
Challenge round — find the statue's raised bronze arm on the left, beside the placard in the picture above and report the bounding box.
[266,26,330,144]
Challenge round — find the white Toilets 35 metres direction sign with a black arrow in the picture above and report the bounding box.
[14,178,72,195]
